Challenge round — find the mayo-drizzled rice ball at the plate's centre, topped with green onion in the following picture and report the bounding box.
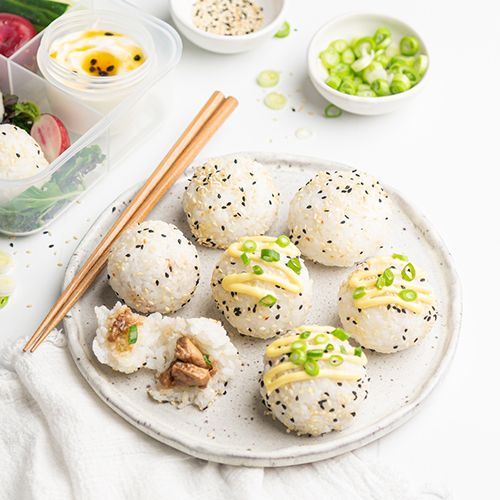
[211,235,312,339]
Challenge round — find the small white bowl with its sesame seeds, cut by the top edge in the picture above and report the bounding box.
[170,0,288,54]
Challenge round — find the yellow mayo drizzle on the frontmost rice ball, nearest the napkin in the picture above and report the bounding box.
[263,325,368,394]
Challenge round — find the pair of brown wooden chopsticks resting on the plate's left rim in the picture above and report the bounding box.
[23,91,238,352]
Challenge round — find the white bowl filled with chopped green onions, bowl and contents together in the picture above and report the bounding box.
[308,14,429,115]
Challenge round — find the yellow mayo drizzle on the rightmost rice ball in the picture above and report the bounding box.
[348,256,434,314]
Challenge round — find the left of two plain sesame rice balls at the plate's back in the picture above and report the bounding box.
[183,157,279,248]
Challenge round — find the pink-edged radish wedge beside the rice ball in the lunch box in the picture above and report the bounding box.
[31,113,71,163]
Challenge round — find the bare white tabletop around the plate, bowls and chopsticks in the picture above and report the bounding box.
[0,0,500,500]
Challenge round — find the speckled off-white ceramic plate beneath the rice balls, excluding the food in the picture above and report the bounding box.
[64,153,461,467]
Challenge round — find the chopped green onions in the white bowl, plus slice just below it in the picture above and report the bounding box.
[319,27,429,97]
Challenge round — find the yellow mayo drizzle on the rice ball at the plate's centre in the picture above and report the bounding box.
[222,236,304,300]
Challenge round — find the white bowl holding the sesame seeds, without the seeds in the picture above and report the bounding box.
[170,0,288,54]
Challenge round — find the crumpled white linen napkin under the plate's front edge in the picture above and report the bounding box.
[0,332,450,500]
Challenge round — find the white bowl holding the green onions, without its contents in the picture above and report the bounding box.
[307,14,429,115]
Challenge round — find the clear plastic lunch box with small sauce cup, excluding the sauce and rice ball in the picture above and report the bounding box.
[0,0,182,235]
